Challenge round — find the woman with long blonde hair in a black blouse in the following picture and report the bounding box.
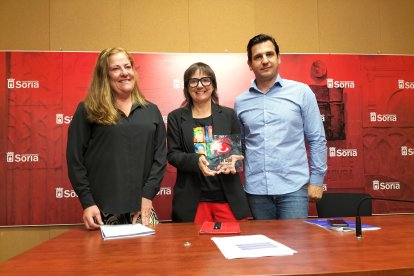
[66,48,166,230]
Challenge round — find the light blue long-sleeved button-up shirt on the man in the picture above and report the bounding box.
[235,75,327,195]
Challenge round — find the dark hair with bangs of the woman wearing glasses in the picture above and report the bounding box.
[181,62,219,107]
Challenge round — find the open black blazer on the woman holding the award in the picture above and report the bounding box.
[167,104,250,222]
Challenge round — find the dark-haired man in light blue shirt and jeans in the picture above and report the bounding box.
[235,34,327,219]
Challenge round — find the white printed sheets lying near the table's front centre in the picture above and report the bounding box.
[211,235,297,259]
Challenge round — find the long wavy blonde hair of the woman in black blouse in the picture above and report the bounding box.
[84,47,148,125]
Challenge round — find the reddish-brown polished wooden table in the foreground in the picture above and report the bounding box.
[0,215,414,275]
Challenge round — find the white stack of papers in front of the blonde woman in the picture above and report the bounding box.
[101,223,155,240]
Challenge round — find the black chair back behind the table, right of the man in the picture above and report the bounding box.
[316,193,372,218]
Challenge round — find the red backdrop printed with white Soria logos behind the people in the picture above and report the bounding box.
[0,52,414,225]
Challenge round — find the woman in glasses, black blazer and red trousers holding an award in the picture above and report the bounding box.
[167,62,249,223]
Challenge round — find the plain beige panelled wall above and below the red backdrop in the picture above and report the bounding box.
[0,0,414,262]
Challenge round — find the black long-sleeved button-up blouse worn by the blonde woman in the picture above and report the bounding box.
[66,103,166,214]
